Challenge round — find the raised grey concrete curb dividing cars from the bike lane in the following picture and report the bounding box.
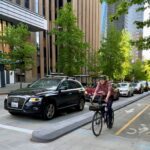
[31,92,150,143]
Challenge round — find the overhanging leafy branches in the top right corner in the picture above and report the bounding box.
[101,0,150,50]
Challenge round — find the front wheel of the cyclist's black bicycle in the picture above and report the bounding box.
[92,111,103,136]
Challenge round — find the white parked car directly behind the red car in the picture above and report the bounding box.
[119,82,134,97]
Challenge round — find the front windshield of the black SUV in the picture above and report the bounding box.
[29,79,61,90]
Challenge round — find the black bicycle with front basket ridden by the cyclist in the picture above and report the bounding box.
[89,97,114,136]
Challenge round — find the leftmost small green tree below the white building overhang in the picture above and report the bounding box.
[0,24,36,86]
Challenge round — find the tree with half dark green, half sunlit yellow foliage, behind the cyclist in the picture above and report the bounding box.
[99,27,131,79]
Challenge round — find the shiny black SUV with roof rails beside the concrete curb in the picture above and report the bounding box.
[4,76,85,119]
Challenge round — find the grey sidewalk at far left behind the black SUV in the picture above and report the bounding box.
[0,82,29,95]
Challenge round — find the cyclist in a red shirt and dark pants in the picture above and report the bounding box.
[92,75,113,126]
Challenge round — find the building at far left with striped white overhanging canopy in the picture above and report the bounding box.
[0,0,47,87]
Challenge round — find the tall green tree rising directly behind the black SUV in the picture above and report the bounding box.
[51,3,88,76]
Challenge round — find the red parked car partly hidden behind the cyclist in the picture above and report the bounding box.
[85,83,120,101]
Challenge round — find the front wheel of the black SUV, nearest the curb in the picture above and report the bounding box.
[43,103,56,120]
